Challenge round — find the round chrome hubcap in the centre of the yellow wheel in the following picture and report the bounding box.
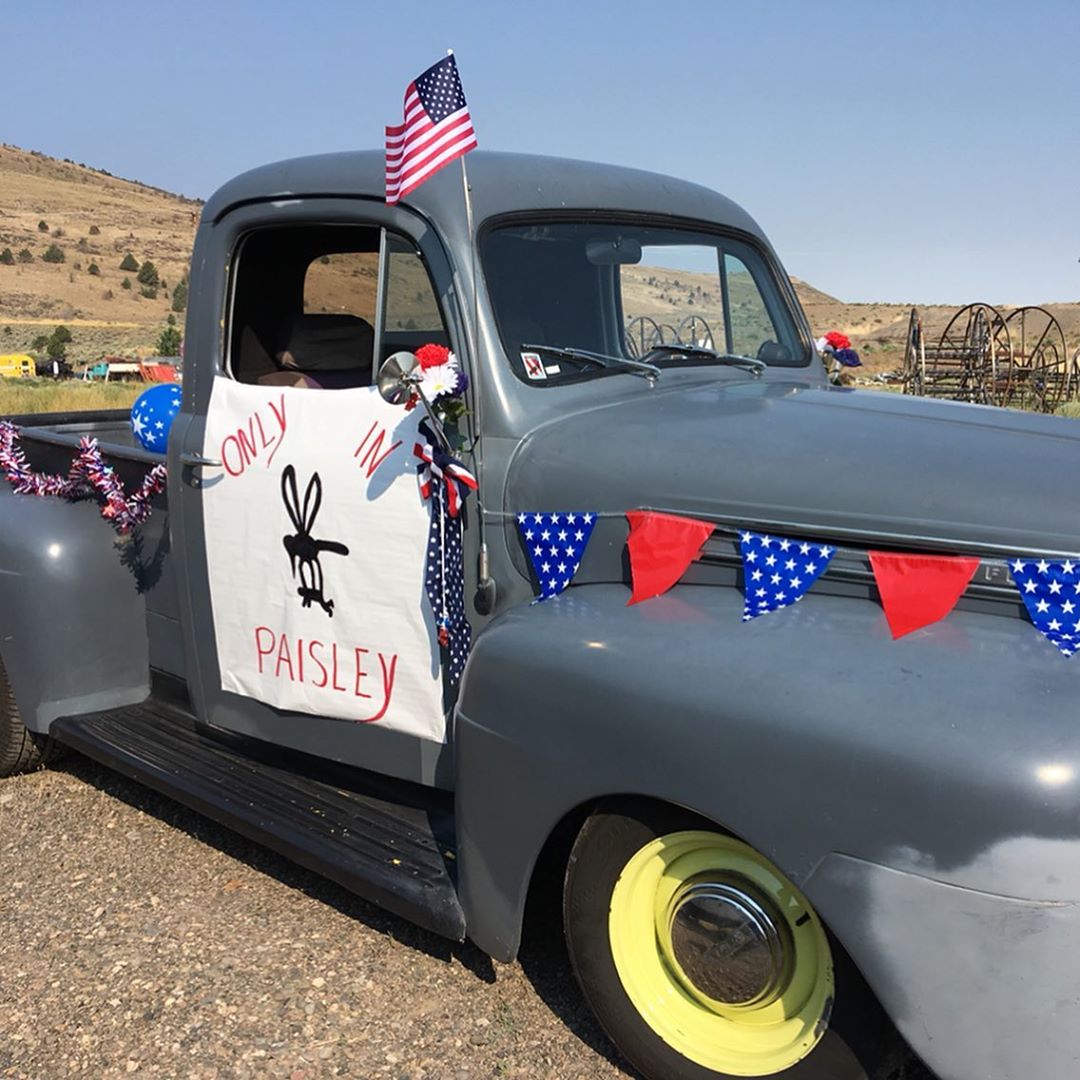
[664,877,792,1010]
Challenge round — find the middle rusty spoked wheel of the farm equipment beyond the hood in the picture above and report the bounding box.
[926,303,1013,405]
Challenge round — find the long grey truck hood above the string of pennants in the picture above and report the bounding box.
[504,381,1080,554]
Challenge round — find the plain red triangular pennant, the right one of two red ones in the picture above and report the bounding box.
[869,551,978,638]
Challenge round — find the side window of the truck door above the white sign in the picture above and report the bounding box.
[226,225,448,390]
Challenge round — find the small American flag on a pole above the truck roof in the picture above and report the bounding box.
[387,55,476,203]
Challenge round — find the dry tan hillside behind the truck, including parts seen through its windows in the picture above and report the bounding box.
[0,145,1080,372]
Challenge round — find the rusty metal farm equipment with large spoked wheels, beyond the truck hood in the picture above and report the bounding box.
[903,303,1080,413]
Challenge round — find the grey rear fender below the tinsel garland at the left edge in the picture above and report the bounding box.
[0,486,149,734]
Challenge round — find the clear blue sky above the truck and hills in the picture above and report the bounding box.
[0,0,1080,303]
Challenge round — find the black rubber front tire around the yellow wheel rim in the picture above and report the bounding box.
[563,799,909,1080]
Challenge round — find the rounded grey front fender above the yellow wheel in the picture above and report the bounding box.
[455,584,1080,972]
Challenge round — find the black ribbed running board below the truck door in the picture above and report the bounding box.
[51,698,465,941]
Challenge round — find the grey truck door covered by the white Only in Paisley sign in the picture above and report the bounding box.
[174,200,475,786]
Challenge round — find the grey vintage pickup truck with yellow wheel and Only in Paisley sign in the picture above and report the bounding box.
[0,152,1080,1080]
